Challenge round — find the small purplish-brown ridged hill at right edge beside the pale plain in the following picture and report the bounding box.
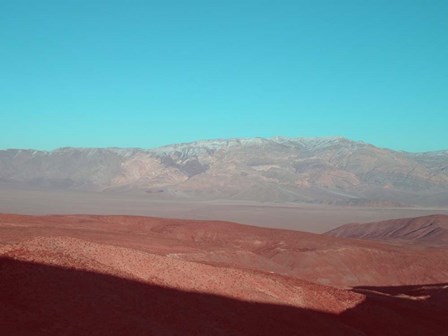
[327,215,448,246]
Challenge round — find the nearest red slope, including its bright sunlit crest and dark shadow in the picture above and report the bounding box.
[0,224,448,336]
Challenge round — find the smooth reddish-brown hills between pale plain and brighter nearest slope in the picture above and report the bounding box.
[0,215,448,287]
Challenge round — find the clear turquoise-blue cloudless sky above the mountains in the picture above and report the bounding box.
[0,0,448,151]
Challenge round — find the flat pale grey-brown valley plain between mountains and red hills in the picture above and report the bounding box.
[0,186,448,233]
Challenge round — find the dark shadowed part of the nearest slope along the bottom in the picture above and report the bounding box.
[0,258,448,335]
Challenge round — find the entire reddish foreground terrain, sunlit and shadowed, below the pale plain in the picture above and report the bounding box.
[0,215,448,335]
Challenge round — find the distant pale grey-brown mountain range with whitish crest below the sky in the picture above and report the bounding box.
[0,137,448,206]
